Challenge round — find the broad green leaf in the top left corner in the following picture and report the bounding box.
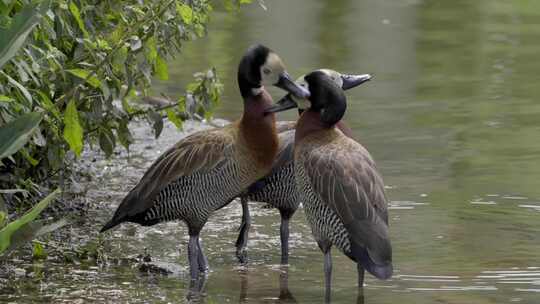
[0,1,51,69]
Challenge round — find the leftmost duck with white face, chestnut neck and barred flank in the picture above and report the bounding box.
[101,45,309,280]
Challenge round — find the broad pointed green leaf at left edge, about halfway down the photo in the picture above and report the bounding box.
[0,112,43,159]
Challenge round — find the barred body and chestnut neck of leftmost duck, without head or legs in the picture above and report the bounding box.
[102,92,278,231]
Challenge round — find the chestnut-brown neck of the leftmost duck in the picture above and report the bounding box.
[240,89,278,166]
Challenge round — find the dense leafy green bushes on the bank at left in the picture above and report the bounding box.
[0,0,250,253]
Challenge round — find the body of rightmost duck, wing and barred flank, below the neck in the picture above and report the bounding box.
[295,124,392,279]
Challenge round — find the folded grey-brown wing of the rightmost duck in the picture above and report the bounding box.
[303,135,392,271]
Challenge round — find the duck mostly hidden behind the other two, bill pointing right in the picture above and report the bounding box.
[236,69,371,264]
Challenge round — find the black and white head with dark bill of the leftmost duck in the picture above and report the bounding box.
[238,44,309,99]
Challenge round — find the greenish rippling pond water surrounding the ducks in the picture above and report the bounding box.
[0,0,540,304]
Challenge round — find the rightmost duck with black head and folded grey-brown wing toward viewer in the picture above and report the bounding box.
[267,71,393,300]
